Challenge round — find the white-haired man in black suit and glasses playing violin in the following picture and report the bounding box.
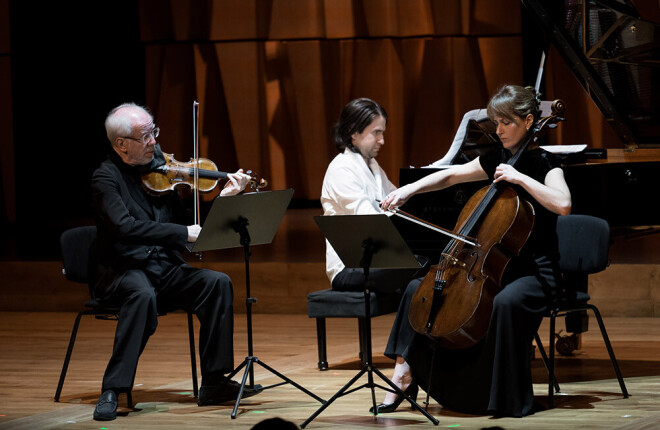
[92,103,258,421]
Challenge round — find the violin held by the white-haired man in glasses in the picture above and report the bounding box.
[142,153,268,195]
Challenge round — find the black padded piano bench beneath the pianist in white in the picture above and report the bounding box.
[307,289,402,370]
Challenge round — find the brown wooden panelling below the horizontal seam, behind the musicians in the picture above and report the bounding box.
[147,36,522,200]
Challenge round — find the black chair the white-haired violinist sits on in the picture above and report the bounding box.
[55,226,198,408]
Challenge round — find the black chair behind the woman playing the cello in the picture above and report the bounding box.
[535,215,628,408]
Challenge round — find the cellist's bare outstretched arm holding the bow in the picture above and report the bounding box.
[380,158,488,210]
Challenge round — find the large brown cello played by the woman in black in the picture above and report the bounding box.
[409,100,564,349]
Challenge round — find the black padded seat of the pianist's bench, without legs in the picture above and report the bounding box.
[307,289,401,318]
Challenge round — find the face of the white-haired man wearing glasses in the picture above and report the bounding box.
[116,110,156,166]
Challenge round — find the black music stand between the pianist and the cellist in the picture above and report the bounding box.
[300,214,438,428]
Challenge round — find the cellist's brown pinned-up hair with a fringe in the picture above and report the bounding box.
[486,85,541,123]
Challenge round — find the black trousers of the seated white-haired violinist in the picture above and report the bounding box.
[102,258,234,392]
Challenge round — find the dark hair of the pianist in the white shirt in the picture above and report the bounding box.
[332,98,387,152]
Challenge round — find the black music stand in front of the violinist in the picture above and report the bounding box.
[192,189,324,419]
